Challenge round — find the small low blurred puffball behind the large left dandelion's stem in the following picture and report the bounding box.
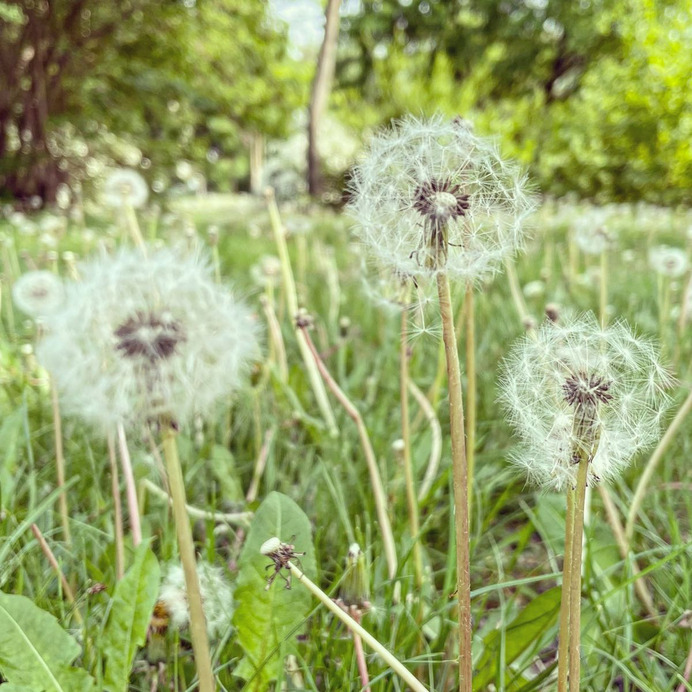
[159,562,233,640]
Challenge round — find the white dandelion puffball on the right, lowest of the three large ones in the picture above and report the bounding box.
[500,313,673,490]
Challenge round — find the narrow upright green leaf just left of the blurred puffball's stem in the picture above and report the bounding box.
[101,544,159,692]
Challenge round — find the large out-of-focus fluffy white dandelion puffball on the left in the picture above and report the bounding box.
[38,248,258,432]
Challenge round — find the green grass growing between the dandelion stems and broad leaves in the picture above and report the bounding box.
[0,192,692,692]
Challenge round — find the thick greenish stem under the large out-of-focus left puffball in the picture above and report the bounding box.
[161,420,216,692]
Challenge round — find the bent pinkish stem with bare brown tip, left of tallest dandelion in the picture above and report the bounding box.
[298,322,398,579]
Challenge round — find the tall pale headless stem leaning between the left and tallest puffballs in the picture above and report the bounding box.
[265,188,338,435]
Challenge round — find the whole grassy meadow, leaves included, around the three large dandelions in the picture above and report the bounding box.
[0,184,692,692]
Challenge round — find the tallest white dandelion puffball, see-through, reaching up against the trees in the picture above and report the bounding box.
[349,116,535,281]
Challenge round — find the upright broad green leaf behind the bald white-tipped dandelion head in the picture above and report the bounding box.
[233,492,315,690]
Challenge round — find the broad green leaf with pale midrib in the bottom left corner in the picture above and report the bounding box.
[0,591,94,692]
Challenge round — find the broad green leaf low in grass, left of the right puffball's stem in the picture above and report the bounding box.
[473,586,561,690]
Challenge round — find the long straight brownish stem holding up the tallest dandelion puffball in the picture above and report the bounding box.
[437,272,472,692]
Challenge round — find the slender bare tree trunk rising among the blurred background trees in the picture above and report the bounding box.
[308,0,341,196]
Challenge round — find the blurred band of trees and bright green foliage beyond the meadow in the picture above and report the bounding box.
[0,0,692,209]
